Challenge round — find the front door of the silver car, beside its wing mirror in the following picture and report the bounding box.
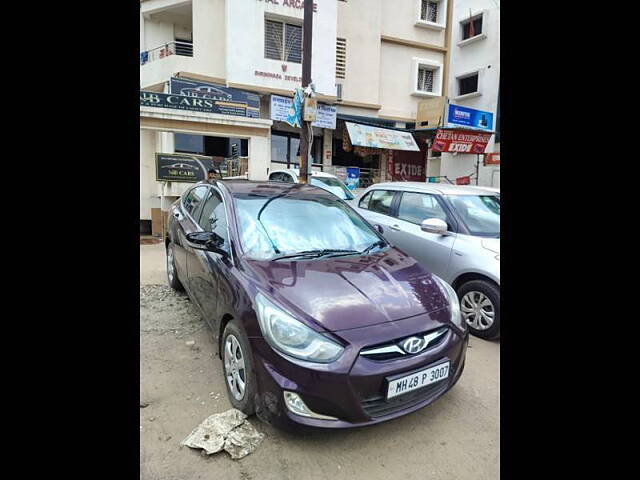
[388,192,456,279]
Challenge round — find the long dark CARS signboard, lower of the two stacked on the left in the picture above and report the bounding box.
[140,90,255,117]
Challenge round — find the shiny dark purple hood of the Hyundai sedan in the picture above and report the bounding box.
[242,247,448,332]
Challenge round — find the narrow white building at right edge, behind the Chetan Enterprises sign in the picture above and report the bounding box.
[438,0,500,187]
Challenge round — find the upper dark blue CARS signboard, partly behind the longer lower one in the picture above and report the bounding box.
[169,77,260,118]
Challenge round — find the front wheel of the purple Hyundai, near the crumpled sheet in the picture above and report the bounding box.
[221,320,258,416]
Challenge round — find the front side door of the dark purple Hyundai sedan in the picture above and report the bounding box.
[187,187,231,327]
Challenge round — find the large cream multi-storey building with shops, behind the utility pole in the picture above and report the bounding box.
[140,0,452,232]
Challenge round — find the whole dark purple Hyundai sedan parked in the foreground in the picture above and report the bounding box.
[166,180,468,428]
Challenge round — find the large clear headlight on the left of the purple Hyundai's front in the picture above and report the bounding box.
[256,293,344,363]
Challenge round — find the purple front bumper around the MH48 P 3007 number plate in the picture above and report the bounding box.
[250,311,468,429]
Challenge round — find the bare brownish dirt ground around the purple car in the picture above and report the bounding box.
[140,244,500,480]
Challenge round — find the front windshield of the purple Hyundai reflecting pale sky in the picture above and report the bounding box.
[235,194,384,260]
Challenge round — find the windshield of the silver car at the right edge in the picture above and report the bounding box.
[449,195,500,238]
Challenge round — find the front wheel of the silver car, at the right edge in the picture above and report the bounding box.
[457,280,500,340]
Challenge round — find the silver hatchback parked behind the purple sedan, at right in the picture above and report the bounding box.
[356,182,500,339]
